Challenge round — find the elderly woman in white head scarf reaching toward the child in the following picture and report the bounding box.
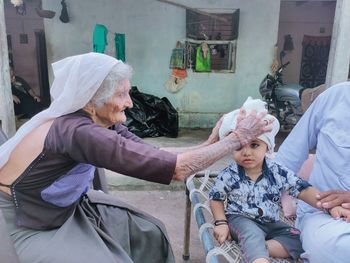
[0,53,270,263]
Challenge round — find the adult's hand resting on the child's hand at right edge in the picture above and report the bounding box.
[316,190,350,209]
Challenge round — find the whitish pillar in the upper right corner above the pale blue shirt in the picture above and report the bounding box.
[326,0,350,88]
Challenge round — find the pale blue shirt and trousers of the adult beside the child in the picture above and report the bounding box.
[276,82,350,263]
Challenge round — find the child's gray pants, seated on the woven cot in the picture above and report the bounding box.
[227,215,303,263]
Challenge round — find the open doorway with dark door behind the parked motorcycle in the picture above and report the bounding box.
[277,0,336,87]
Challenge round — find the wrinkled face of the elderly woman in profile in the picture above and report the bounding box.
[94,79,132,127]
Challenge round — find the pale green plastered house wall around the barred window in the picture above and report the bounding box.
[43,0,280,128]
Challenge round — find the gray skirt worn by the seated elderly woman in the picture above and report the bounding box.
[0,191,175,263]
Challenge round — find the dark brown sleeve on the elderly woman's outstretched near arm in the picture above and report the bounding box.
[47,117,177,184]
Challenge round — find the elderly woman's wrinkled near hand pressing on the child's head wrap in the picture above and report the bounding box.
[233,108,273,146]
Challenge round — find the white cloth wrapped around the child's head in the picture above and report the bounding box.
[219,97,280,153]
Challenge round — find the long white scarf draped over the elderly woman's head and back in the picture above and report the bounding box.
[0,52,122,168]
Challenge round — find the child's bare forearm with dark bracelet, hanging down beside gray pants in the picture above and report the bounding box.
[209,200,231,245]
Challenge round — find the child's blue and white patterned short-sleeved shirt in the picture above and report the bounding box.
[209,158,311,222]
